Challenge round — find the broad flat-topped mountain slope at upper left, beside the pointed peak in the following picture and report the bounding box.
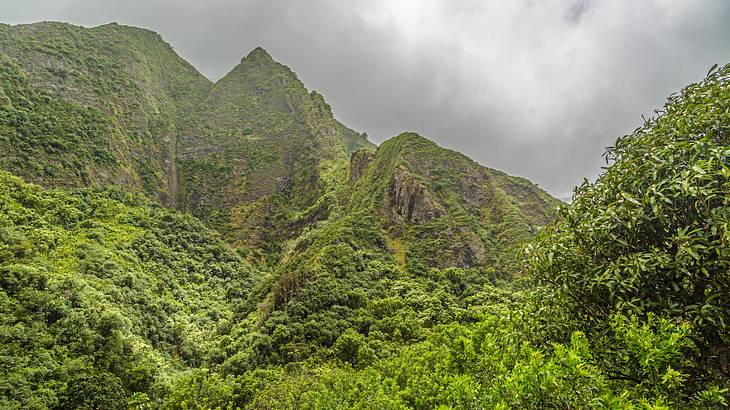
[0,22,211,205]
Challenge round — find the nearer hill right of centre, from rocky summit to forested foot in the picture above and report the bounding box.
[216,133,560,373]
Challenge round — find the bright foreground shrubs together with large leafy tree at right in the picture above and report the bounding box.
[190,65,730,409]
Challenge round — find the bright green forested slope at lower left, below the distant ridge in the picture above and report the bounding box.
[0,172,251,408]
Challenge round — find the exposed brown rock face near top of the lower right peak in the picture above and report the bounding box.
[387,165,444,223]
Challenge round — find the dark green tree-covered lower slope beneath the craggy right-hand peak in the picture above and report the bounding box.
[203,201,510,374]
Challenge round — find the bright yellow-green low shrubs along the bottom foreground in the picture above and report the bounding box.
[245,305,726,409]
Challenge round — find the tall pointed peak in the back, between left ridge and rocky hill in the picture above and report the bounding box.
[179,48,373,262]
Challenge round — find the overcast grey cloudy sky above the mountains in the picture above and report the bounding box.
[0,0,730,199]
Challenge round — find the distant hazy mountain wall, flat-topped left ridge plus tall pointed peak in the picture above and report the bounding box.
[0,22,374,266]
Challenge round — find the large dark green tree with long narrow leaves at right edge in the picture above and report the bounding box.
[530,66,730,383]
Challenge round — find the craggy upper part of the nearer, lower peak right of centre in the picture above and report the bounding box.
[350,133,560,269]
